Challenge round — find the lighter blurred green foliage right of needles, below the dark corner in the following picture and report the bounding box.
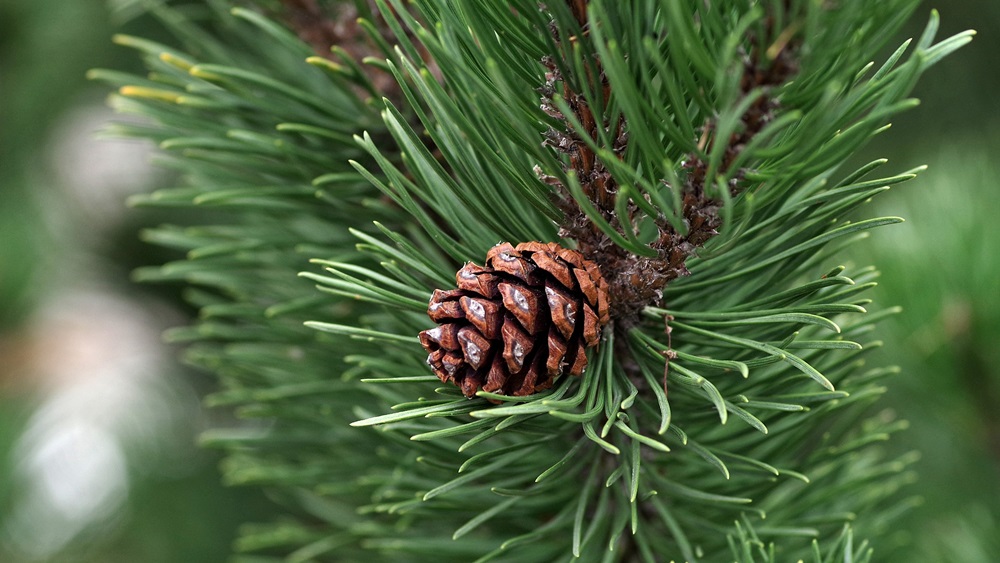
[870,136,1000,563]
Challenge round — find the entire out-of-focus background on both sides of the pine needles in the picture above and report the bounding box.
[0,0,1000,562]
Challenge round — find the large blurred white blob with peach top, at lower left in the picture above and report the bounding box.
[0,291,199,561]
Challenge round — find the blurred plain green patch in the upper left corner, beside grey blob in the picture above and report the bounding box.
[0,0,118,330]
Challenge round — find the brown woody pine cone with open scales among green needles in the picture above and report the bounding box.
[420,242,609,397]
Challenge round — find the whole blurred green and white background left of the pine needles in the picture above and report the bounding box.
[0,0,267,563]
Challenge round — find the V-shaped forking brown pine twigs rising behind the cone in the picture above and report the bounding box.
[541,0,801,331]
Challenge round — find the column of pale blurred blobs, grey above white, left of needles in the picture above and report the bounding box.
[0,94,201,561]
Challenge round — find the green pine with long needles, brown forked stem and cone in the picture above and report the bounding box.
[93,0,972,562]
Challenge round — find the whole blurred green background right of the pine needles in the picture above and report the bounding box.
[858,4,1000,563]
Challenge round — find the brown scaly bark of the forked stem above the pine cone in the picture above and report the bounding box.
[540,0,798,334]
